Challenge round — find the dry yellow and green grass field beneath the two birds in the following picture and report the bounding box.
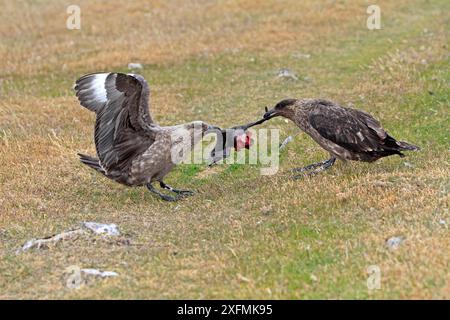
[0,0,450,299]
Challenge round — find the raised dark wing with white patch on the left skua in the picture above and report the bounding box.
[74,73,155,172]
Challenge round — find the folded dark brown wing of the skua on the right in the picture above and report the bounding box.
[309,101,395,152]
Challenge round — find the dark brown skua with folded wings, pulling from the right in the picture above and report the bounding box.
[264,99,419,176]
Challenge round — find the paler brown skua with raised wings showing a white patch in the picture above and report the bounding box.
[75,73,219,201]
